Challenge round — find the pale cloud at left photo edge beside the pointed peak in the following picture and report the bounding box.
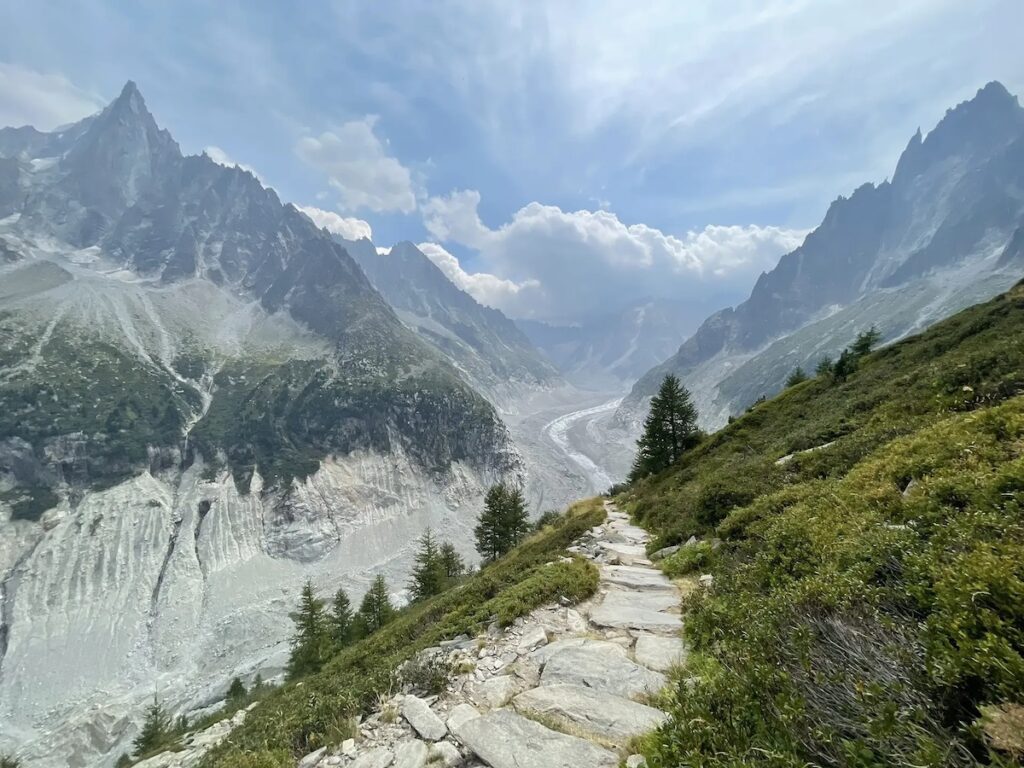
[0,62,103,131]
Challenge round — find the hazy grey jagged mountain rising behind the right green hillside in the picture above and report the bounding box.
[620,83,1024,427]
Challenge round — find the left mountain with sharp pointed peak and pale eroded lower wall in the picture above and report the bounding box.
[0,83,522,766]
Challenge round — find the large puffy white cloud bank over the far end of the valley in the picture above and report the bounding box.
[422,189,806,321]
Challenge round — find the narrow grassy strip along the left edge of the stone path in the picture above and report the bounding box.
[195,500,604,768]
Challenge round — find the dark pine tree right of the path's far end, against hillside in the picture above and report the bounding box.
[630,374,700,481]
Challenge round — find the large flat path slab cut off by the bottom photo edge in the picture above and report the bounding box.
[455,710,618,768]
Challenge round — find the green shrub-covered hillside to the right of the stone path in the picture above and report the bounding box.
[624,284,1024,768]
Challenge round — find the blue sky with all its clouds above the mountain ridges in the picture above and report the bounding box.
[0,0,1024,323]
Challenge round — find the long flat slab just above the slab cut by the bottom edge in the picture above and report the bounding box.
[512,684,669,746]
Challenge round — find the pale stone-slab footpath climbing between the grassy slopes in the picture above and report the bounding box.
[136,503,685,768]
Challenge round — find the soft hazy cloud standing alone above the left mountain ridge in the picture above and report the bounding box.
[295,116,416,213]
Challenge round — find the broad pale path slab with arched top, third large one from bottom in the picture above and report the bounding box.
[541,640,668,698]
